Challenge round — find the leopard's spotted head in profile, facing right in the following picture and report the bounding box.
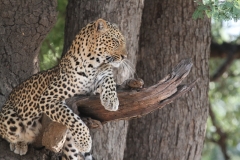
[76,19,127,67]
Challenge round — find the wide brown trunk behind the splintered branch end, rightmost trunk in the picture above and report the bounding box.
[124,0,211,160]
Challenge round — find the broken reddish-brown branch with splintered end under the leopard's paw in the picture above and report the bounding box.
[70,59,196,123]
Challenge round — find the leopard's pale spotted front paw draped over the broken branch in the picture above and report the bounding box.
[100,92,119,111]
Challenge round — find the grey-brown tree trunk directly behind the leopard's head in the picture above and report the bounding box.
[63,0,143,160]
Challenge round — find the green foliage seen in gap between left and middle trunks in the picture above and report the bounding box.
[39,0,67,70]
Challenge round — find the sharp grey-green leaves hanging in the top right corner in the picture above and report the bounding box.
[192,0,240,21]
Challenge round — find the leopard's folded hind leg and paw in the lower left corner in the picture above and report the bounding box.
[0,108,41,155]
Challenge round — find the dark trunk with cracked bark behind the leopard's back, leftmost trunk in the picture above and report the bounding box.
[0,0,57,160]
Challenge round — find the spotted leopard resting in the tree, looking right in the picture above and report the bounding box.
[0,18,127,159]
